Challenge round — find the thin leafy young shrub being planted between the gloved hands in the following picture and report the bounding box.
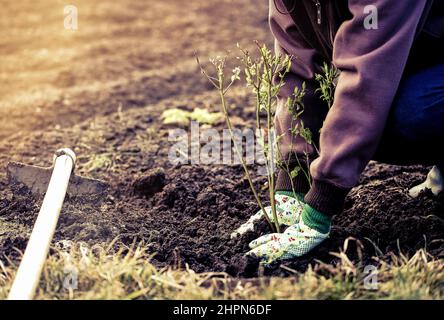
[197,42,316,232]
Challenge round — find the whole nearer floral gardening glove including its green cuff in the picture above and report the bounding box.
[247,204,331,265]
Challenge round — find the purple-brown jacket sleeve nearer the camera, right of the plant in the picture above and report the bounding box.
[306,0,426,214]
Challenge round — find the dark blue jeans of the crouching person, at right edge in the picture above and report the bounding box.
[375,63,444,168]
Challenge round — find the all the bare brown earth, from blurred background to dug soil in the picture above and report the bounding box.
[0,0,444,277]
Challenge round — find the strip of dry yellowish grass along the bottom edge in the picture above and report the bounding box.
[0,244,444,299]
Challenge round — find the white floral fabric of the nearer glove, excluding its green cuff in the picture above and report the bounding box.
[247,209,330,265]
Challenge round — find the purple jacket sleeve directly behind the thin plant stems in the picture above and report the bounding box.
[269,0,328,193]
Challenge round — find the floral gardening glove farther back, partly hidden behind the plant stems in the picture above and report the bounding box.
[231,191,304,239]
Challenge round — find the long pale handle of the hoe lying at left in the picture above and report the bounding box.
[8,149,76,300]
